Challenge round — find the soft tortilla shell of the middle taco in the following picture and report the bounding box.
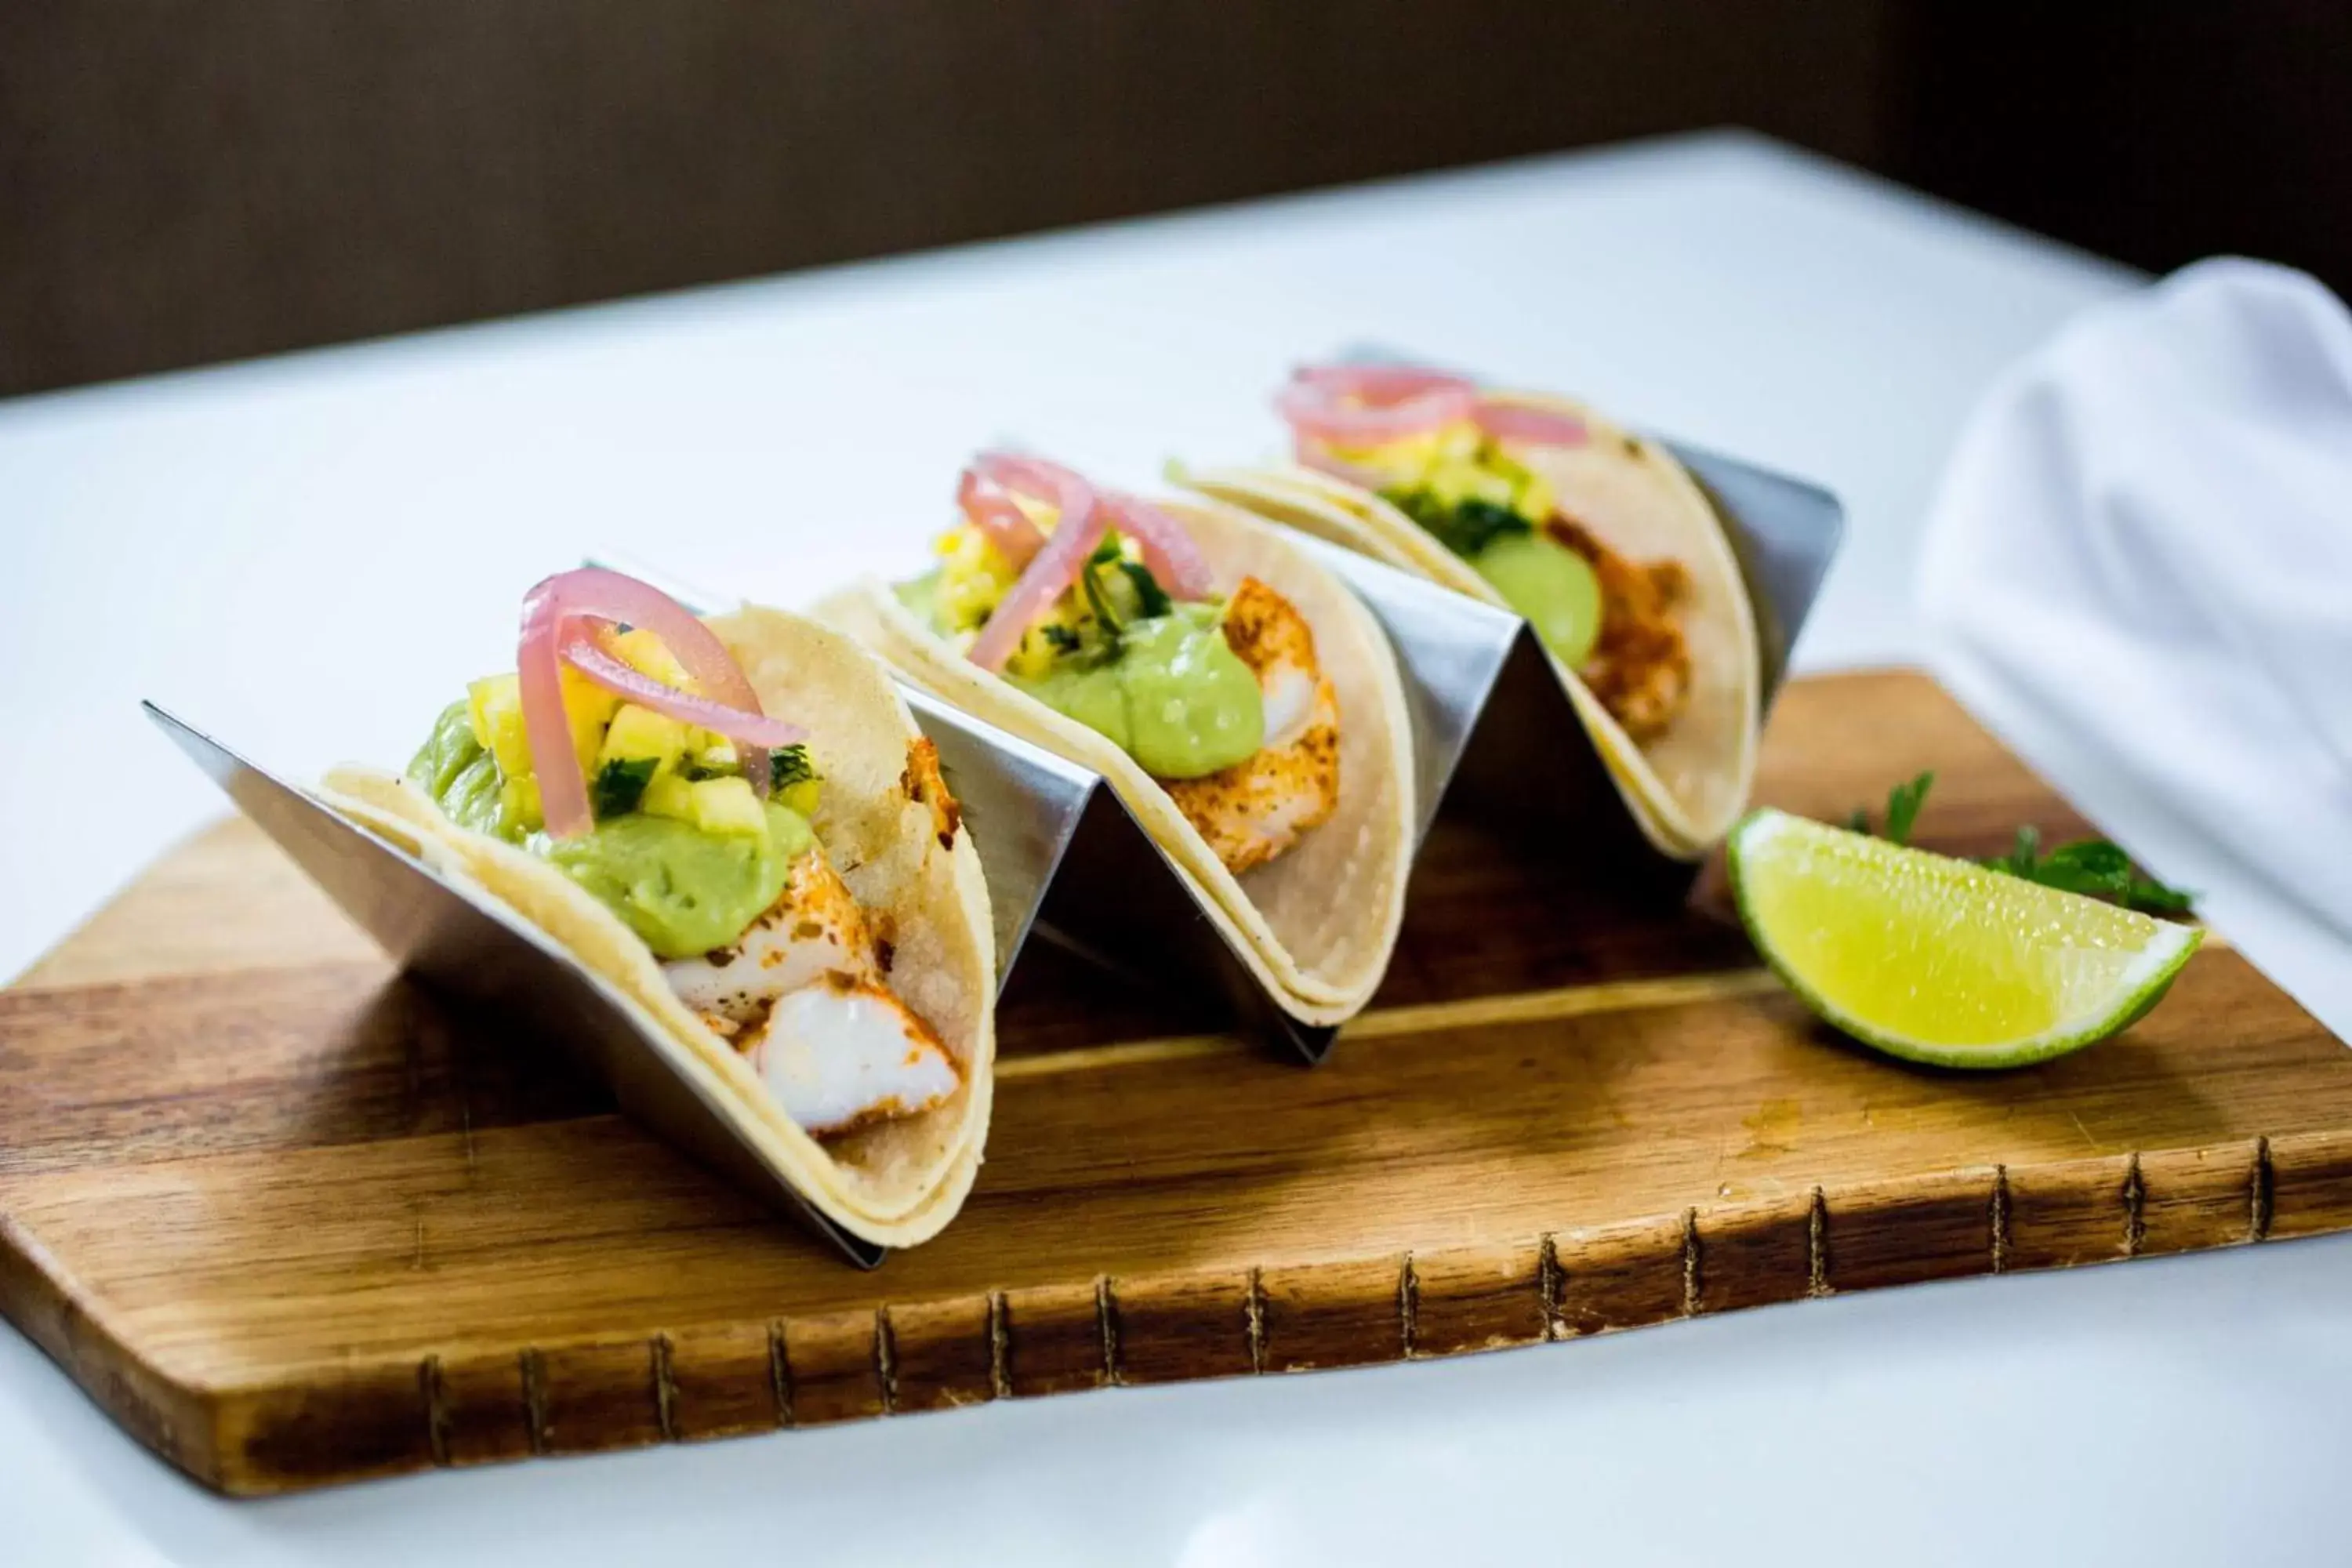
[816,501,1416,1025]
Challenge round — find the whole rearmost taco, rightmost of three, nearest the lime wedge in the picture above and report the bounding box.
[1174,367,1762,858]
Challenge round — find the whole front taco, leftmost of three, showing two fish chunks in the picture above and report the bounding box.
[325,569,995,1246]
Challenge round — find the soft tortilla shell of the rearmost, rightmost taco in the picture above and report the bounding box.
[1178,393,1762,860]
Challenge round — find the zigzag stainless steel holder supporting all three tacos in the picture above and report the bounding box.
[143,425,1844,1267]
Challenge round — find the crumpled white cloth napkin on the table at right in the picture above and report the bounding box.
[1919,261,2352,945]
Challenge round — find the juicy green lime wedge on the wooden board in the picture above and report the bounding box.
[1731,811,2204,1067]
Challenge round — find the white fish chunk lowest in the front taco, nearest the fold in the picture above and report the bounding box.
[739,978,962,1135]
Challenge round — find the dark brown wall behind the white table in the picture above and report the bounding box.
[0,0,2352,395]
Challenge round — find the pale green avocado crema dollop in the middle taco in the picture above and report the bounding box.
[1004,604,1265,779]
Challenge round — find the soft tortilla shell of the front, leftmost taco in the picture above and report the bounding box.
[322,609,995,1246]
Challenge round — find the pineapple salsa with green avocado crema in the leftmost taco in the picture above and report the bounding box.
[409,630,818,959]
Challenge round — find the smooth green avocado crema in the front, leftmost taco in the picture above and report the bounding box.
[409,703,816,959]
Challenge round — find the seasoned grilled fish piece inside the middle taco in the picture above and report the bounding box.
[1162,579,1338,874]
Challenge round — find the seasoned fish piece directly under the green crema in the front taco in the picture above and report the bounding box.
[661,848,880,1034]
